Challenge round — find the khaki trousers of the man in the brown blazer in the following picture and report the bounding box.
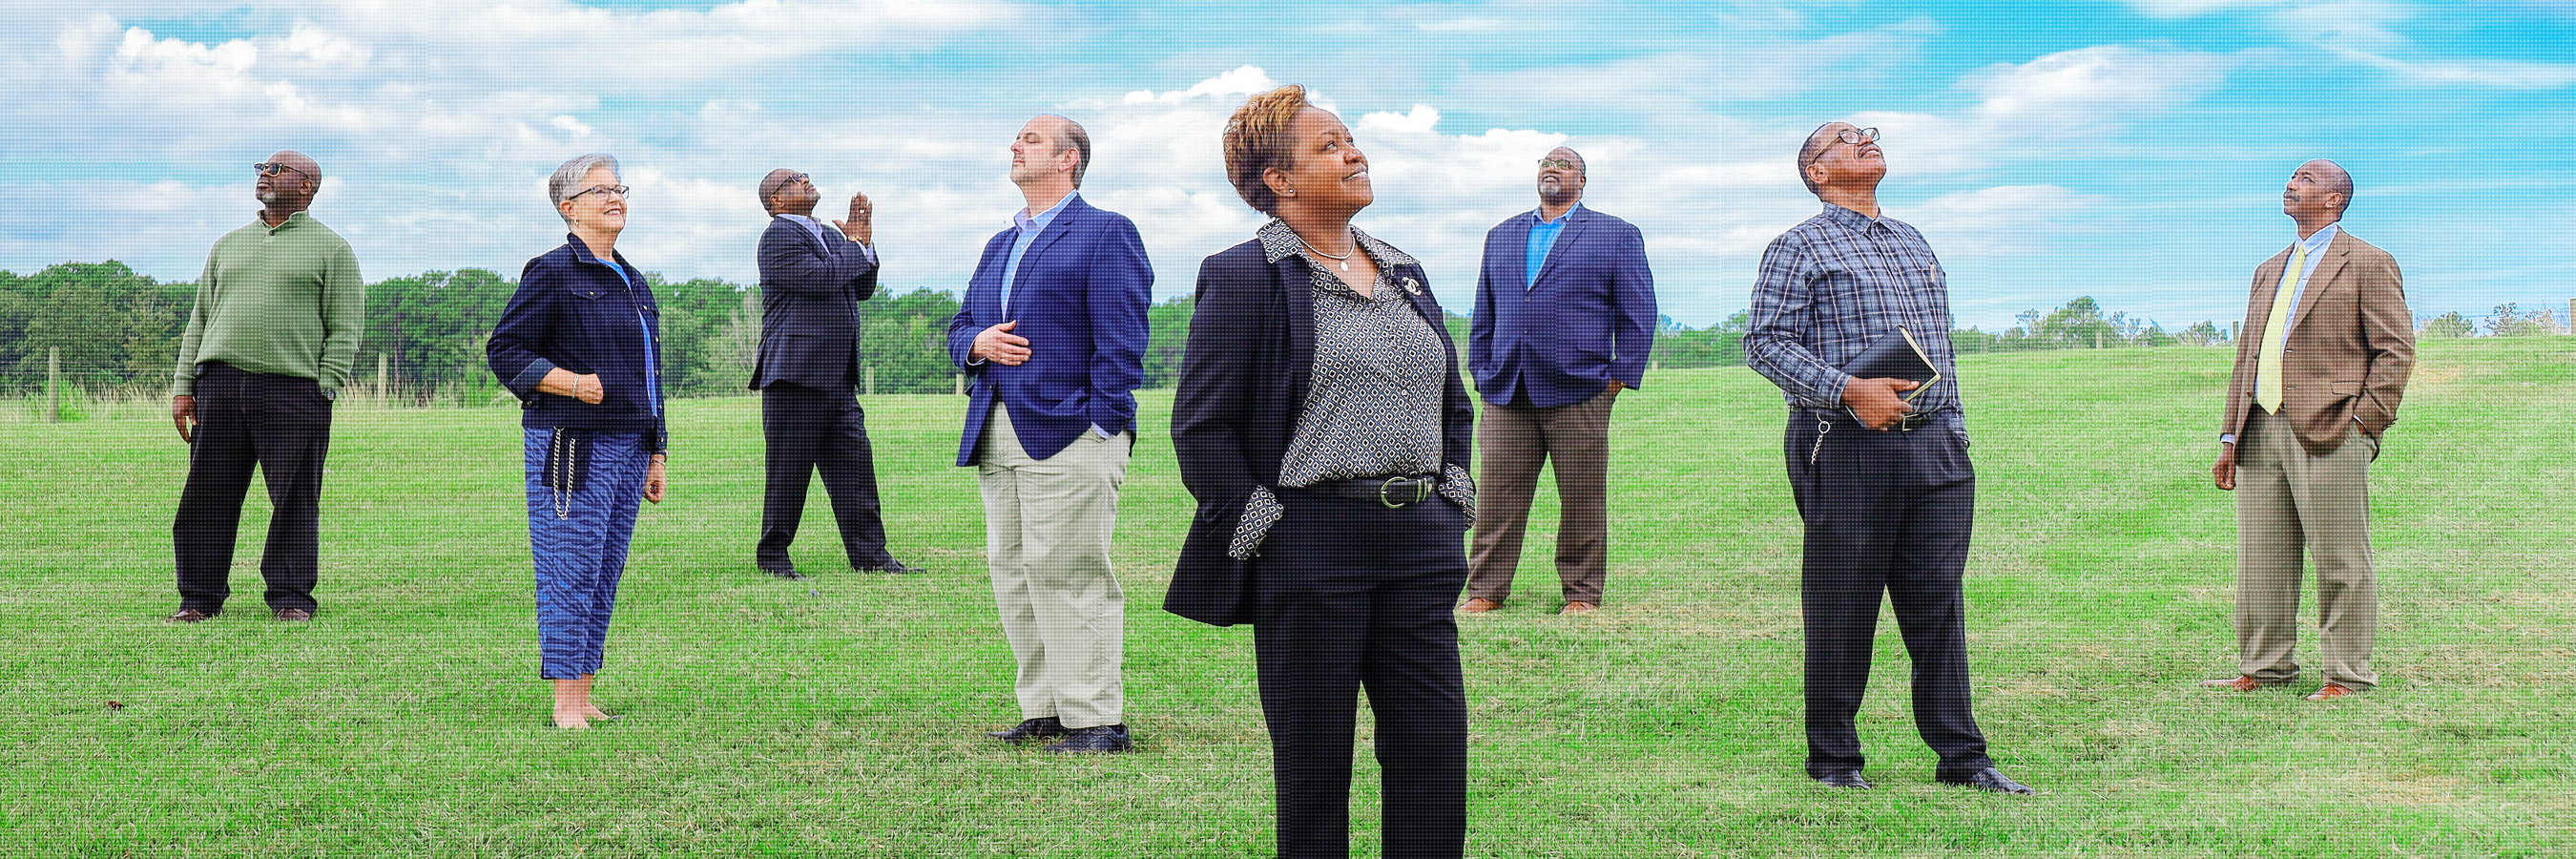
[2236,408,2380,689]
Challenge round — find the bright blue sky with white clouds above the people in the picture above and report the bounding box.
[0,0,2576,330]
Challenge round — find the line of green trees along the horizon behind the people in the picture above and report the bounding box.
[0,261,2568,405]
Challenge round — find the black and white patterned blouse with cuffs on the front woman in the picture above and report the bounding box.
[1226,220,1476,557]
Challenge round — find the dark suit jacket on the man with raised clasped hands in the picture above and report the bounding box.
[752,217,876,389]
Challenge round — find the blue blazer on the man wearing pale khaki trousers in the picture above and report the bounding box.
[948,196,1154,464]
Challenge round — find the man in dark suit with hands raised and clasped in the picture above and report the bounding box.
[752,168,920,577]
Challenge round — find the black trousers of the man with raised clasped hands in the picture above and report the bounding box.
[752,382,891,570]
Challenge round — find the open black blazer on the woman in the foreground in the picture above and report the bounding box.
[1162,240,1476,627]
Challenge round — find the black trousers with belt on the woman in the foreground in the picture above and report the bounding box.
[1252,491,1465,859]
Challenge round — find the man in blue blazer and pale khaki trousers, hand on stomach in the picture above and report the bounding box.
[948,116,1154,753]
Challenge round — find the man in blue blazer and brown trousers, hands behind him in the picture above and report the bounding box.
[1458,147,1656,614]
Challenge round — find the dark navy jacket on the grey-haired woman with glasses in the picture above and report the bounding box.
[485,235,670,454]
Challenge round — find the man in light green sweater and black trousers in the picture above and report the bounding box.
[170,152,365,624]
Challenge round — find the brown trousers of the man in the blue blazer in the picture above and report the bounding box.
[1465,395,1615,603]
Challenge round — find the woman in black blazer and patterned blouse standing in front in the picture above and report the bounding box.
[1164,85,1476,856]
